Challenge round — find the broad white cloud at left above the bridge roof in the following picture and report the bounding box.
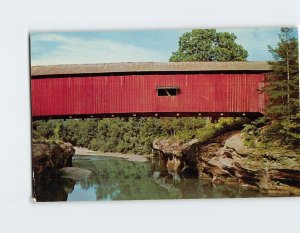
[31,33,167,65]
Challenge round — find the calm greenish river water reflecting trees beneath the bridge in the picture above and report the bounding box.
[34,156,262,201]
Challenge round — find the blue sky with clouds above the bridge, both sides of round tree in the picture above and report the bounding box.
[30,27,296,65]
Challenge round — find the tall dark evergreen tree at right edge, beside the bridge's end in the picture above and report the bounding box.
[261,28,300,147]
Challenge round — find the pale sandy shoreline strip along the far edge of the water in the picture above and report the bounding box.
[74,146,150,162]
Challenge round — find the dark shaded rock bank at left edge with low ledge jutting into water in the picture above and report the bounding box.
[32,139,91,201]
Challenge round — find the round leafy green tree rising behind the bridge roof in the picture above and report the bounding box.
[170,29,248,62]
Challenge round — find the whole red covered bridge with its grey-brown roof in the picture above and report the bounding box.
[31,62,270,119]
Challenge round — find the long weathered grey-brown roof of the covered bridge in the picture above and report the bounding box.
[31,62,271,76]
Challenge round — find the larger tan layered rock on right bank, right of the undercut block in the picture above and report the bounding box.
[198,133,300,196]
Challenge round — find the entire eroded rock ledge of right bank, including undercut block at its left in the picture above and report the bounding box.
[153,131,300,196]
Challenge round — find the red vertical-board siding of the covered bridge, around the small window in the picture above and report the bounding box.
[31,73,265,117]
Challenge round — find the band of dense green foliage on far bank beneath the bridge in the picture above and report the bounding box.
[33,117,245,154]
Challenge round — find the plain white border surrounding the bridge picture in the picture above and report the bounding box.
[0,0,300,233]
